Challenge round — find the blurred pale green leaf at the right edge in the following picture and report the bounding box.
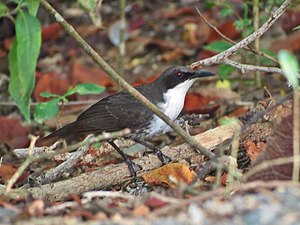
[278,50,299,90]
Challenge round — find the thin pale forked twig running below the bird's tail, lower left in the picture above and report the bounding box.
[6,129,130,193]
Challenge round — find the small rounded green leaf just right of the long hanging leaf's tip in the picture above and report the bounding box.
[34,98,59,123]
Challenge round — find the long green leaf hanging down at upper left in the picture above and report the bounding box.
[8,10,41,122]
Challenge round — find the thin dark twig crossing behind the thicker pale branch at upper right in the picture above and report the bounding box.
[195,6,279,65]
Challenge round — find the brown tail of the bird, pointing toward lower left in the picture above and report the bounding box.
[36,122,75,146]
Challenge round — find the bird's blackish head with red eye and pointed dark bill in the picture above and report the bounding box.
[155,66,214,91]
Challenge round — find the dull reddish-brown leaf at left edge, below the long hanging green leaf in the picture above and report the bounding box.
[0,116,30,148]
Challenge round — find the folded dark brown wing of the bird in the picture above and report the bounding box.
[75,92,152,133]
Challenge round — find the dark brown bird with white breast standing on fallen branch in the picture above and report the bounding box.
[38,66,214,177]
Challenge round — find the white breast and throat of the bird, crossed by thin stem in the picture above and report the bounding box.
[148,79,195,136]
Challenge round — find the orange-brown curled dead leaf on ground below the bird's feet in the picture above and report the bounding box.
[142,163,196,187]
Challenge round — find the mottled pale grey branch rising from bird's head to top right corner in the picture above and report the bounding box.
[190,0,291,69]
